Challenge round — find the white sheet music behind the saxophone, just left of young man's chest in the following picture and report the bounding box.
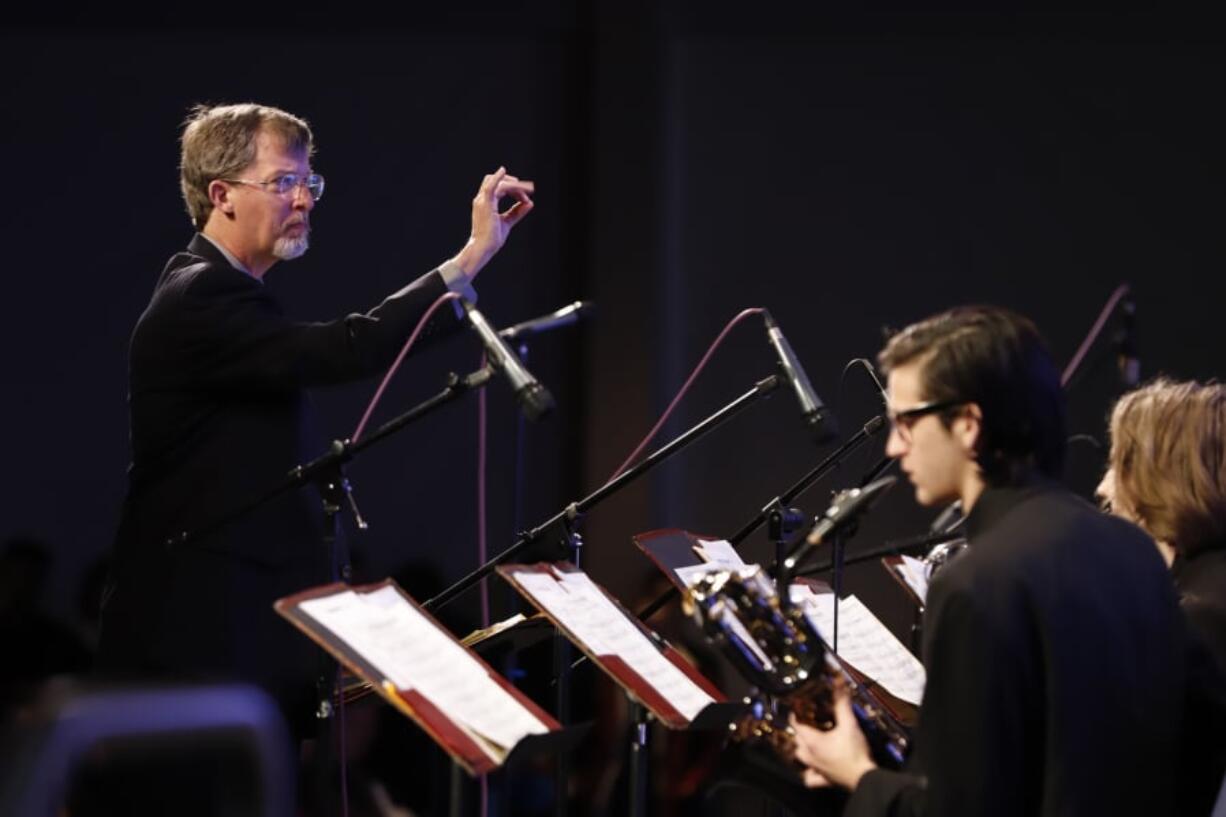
[791,584,924,707]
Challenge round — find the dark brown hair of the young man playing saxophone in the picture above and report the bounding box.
[878,307,1065,485]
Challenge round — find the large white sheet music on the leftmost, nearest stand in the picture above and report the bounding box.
[299,585,548,748]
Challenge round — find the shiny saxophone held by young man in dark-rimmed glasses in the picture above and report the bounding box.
[683,567,910,768]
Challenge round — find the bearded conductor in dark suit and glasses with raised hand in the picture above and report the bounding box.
[99,104,533,736]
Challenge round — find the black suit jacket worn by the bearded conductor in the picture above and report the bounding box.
[99,234,459,726]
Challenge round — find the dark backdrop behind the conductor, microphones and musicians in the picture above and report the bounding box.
[0,0,1226,809]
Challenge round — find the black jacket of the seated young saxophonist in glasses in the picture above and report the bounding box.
[845,485,1184,817]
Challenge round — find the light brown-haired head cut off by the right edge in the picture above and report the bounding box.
[1098,379,1226,556]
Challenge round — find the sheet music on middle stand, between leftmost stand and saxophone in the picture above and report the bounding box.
[515,570,714,720]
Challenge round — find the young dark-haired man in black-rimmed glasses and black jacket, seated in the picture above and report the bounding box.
[797,308,1184,817]
